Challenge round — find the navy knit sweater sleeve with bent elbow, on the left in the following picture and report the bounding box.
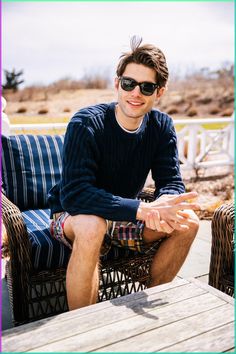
[60,122,140,222]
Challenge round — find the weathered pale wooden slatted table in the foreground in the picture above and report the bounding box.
[2,279,234,352]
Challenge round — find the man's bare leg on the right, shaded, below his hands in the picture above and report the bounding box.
[144,211,199,287]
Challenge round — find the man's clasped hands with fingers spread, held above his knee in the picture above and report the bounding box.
[137,192,200,233]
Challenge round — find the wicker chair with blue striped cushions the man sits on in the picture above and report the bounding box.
[2,135,160,325]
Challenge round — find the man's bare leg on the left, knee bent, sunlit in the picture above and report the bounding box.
[64,215,106,310]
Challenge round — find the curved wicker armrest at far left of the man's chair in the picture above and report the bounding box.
[2,193,32,318]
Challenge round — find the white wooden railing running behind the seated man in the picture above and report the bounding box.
[2,96,234,171]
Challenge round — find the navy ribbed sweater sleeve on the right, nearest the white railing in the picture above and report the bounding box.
[152,116,185,198]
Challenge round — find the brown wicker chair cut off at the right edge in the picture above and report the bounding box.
[209,204,235,296]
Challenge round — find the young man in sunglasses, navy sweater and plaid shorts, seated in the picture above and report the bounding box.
[49,38,199,309]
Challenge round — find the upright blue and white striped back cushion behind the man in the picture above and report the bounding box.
[2,135,64,210]
